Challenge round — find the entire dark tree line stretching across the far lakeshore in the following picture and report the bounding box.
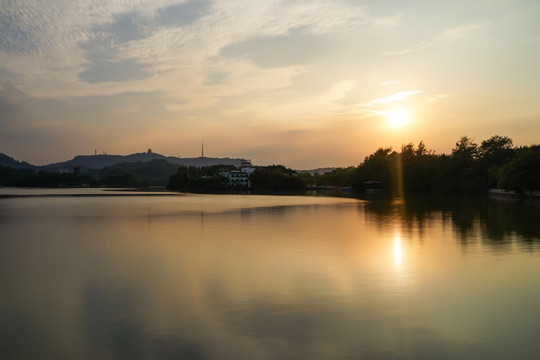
[0,135,540,195]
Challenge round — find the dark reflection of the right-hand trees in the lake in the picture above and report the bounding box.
[359,194,540,245]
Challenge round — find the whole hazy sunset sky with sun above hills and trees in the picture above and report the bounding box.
[0,0,540,169]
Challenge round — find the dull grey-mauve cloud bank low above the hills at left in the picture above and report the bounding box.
[0,85,181,163]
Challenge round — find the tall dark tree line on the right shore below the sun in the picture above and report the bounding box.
[313,135,540,194]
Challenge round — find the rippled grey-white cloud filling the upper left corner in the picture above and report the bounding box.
[0,0,215,88]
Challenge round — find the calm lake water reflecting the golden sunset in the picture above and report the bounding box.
[0,189,540,360]
